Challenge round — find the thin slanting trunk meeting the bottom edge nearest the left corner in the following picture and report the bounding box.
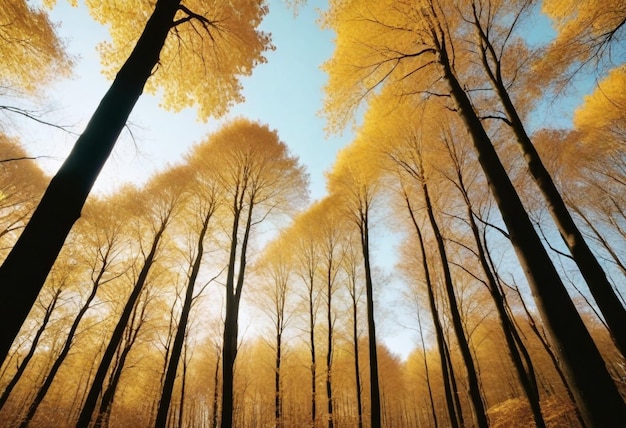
[22,262,109,427]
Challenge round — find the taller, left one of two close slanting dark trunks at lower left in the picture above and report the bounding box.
[76,216,169,428]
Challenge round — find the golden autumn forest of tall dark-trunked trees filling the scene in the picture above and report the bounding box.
[0,0,626,428]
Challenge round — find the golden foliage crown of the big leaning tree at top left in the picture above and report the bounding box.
[78,0,273,121]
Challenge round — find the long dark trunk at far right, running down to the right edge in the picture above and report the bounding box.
[474,12,626,357]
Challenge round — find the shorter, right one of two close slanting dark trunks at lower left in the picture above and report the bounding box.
[94,301,147,428]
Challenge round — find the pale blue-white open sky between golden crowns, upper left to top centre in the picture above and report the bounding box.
[29,0,351,198]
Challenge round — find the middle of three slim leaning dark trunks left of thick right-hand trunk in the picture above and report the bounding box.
[419,169,489,428]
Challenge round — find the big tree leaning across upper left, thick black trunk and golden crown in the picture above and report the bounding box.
[0,0,271,360]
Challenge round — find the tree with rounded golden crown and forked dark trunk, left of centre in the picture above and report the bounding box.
[192,119,307,427]
